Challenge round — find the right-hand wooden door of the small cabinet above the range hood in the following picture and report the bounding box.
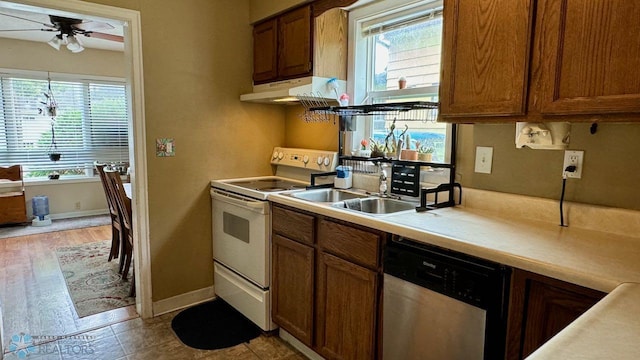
[278,6,312,78]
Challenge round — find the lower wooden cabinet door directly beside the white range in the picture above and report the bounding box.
[271,234,314,347]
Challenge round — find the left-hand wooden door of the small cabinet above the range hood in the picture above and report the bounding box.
[253,19,278,83]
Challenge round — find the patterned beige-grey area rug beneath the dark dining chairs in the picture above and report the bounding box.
[56,240,136,317]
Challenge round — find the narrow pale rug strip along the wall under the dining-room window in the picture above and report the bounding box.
[0,214,111,239]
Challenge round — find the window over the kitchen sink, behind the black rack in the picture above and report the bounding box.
[348,0,451,180]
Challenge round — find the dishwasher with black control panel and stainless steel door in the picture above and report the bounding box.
[383,236,511,360]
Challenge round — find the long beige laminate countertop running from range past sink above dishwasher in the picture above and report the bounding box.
[269,194,640,292]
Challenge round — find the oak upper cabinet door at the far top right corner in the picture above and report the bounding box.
[534,0,640,114]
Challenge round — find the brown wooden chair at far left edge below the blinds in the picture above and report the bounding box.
[0,165,27,225]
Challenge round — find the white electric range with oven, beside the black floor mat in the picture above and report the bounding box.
[210,147,338,331]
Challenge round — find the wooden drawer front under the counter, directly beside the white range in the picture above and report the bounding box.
[271,206,315,244]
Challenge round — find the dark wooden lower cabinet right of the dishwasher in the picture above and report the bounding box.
[506,269,606,360]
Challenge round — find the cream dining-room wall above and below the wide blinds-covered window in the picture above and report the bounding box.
[0,38,125,219]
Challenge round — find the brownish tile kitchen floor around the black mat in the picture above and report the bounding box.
[5,312,306,360]
